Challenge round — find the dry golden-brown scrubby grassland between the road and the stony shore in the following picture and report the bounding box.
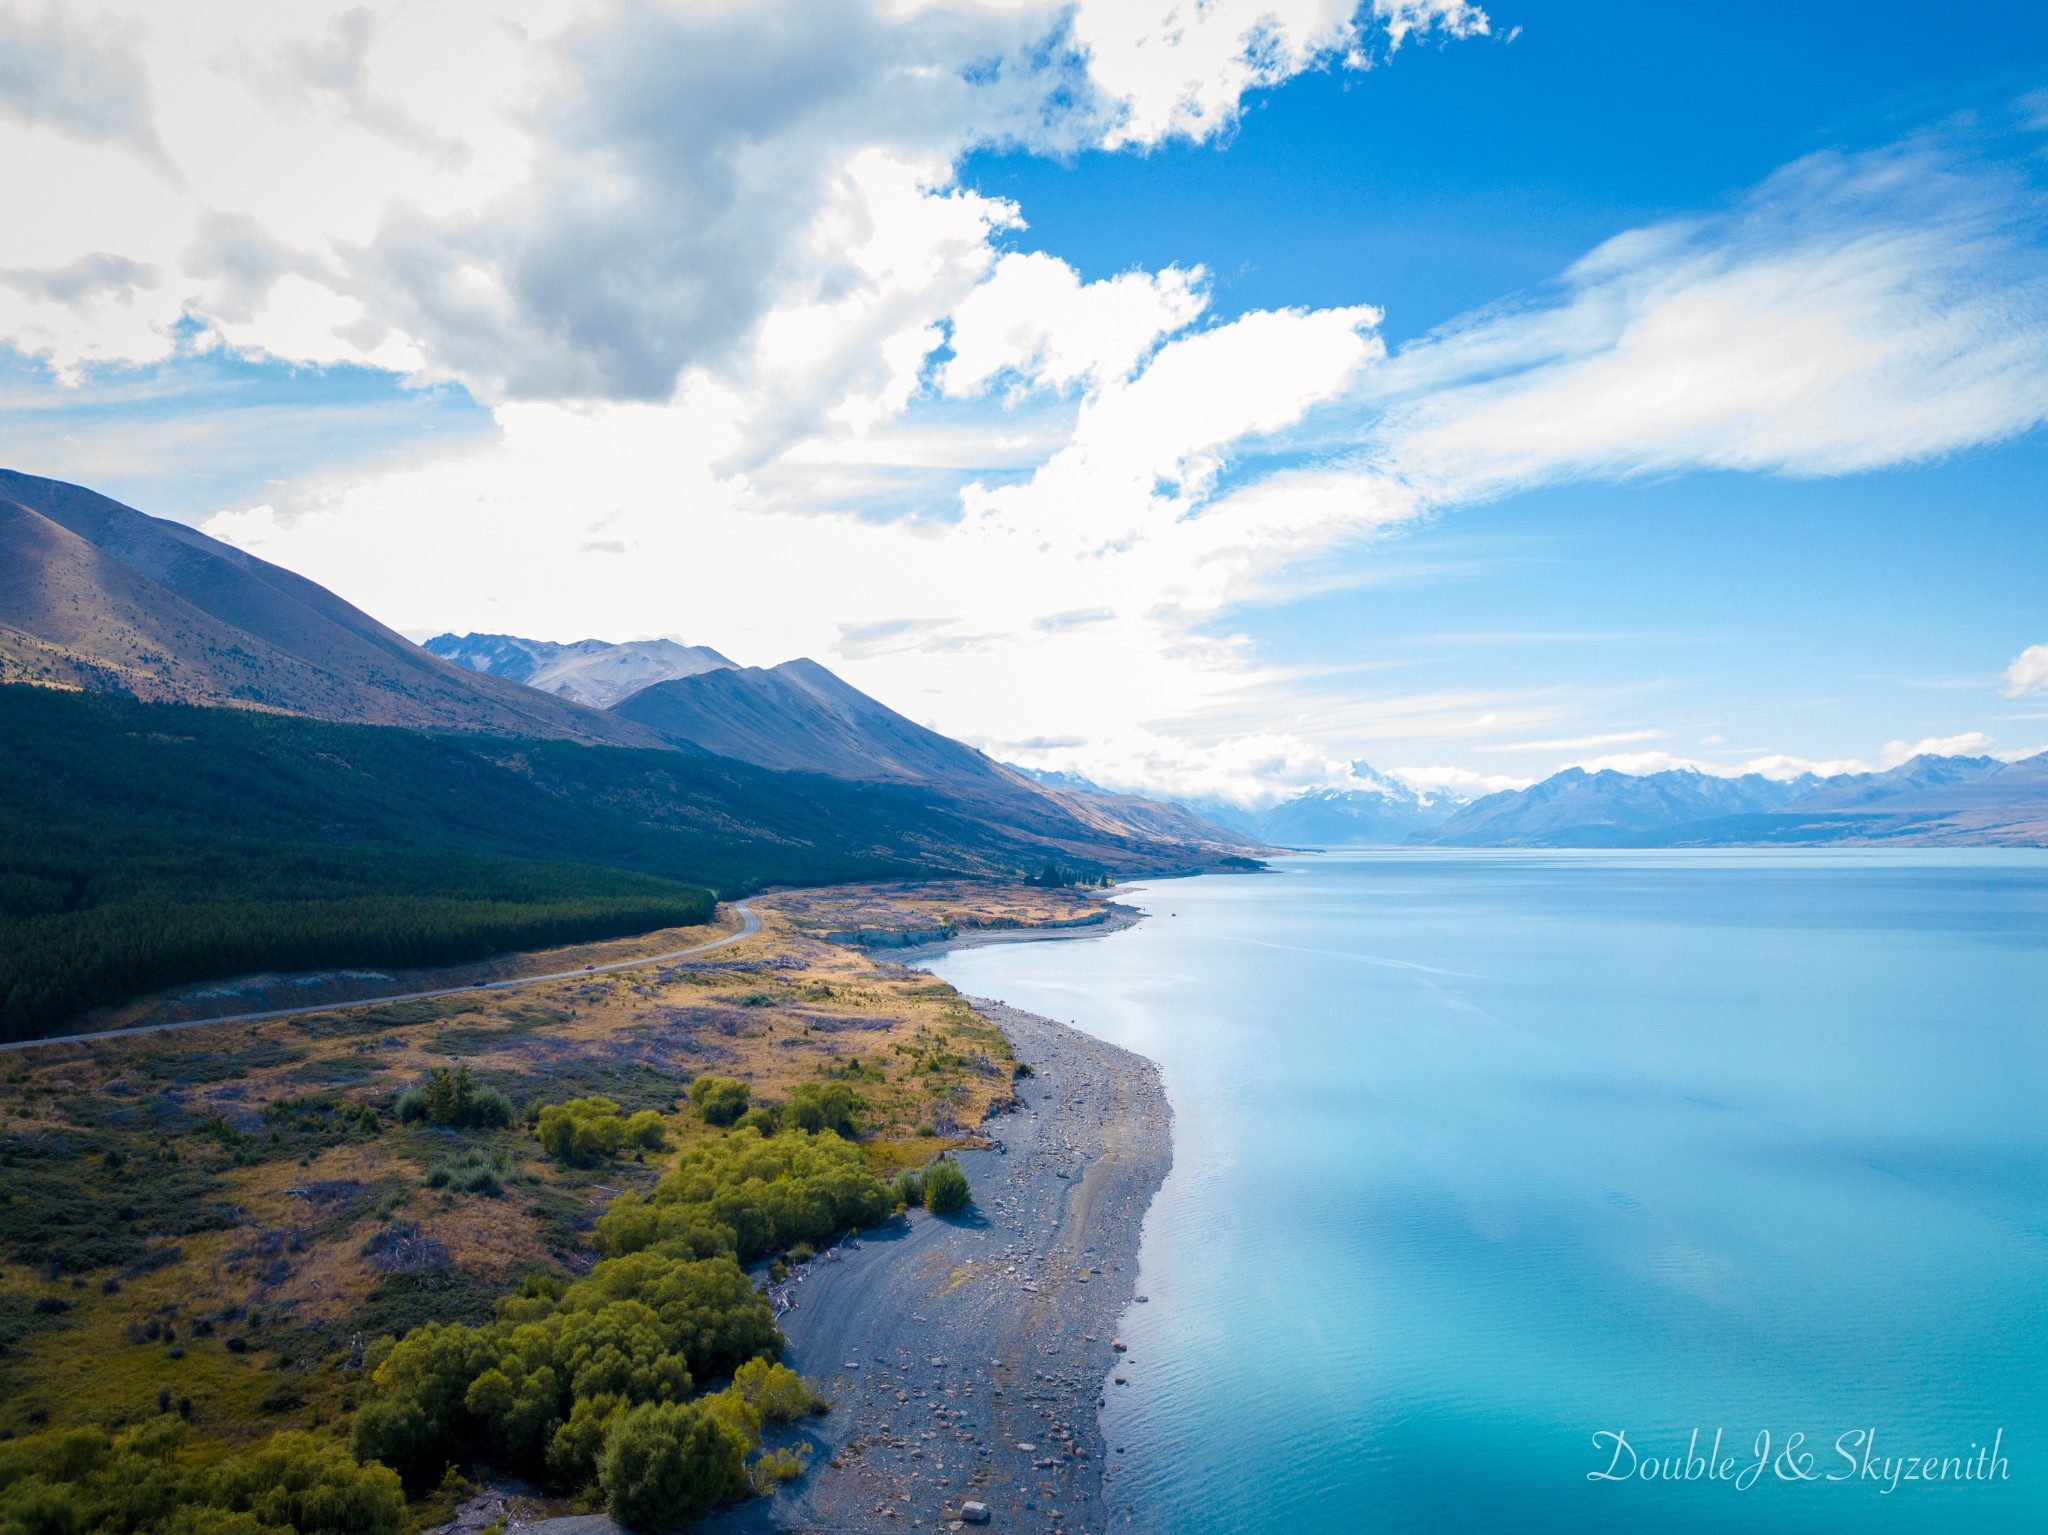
[0,884,1085,1441]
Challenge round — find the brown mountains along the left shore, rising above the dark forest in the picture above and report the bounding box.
[0,471,1255,872]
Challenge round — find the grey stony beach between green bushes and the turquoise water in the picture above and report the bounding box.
[702,999,1174,1535]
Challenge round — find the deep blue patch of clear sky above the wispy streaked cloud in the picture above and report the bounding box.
[961,0,2048,342]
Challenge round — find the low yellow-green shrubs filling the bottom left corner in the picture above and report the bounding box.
[0,1414,406,1535]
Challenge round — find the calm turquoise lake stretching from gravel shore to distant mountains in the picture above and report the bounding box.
[928,851,2048,1535]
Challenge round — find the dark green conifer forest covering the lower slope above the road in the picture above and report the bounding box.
[0,686,1056,1038]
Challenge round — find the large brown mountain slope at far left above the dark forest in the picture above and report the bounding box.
[0,471,662,745]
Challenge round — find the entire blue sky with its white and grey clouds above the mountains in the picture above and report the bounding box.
[0,0,2048,798]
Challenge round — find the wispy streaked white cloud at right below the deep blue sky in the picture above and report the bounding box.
[1364,141,2048,503]
